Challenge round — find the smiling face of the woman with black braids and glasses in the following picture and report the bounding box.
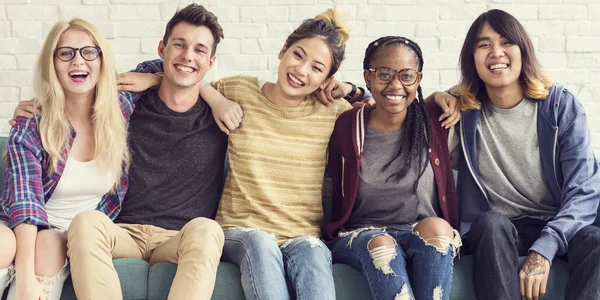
[364,44,422,116]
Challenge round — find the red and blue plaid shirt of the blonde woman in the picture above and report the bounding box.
[0,61,162,228]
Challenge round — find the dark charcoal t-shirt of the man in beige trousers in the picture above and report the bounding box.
[115,90,227,230]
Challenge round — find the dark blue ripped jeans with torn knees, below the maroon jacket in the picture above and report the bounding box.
[331,228,455,300]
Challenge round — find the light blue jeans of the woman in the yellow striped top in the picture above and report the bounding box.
[221,228,335,300]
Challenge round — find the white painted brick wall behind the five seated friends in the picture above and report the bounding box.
[0,0,600,154]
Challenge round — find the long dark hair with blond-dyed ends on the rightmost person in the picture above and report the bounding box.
[453,9,551,111]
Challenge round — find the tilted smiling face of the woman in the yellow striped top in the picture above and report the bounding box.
[276,38,332,99]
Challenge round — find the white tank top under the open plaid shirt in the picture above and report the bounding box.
[46,157,113,231]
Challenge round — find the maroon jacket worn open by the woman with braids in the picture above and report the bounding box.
[322,102,458,245]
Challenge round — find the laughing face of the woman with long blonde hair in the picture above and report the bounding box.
[54,29,102,98]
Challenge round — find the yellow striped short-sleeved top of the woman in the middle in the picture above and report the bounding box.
[213,76,351,243]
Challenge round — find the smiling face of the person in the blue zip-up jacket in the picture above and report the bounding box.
[473,22,522,95]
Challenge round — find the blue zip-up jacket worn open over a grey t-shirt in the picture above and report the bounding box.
[457,85,600,261]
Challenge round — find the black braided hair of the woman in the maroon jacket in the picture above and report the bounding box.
[363,36,431,192]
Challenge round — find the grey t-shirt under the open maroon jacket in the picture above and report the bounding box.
[348,128,439,230]
